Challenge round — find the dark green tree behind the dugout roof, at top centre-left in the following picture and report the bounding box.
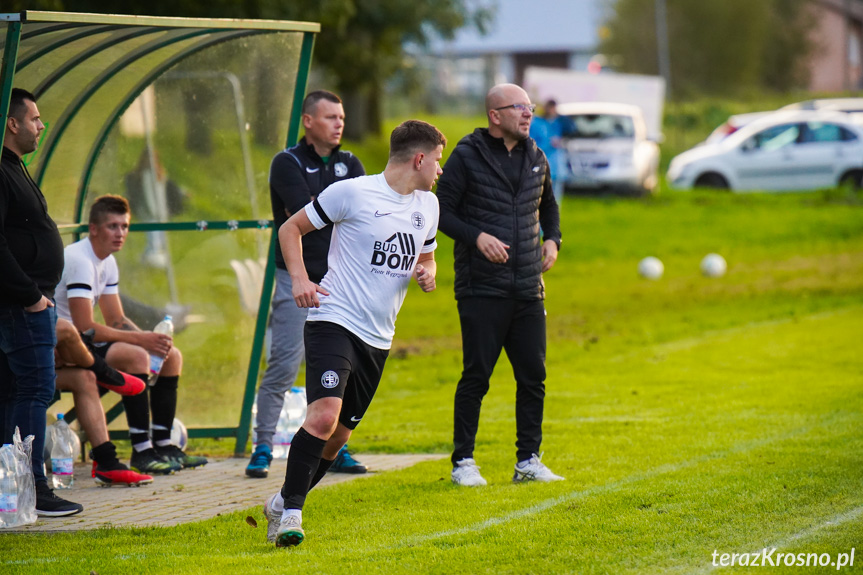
[2,0,492,139]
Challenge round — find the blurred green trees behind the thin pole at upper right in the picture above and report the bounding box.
[600,0,818,98]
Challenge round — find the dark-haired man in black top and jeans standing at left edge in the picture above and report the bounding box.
[0,88,84,517]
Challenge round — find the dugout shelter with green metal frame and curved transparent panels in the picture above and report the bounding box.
[0,11,320,454]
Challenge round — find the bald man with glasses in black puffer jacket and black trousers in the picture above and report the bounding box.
[437,84,562,486]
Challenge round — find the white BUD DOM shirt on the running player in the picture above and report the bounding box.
[305,174,439,349]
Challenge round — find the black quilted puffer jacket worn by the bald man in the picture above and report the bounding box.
[438,128,560,300]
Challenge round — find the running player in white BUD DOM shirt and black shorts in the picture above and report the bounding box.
[264,120,446,547]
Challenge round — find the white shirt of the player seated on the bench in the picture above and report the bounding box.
[54,238,120,321]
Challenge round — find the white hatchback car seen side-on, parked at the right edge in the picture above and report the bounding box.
[668,110,863,190]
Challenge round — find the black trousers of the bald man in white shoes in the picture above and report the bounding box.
[452,297,545,464]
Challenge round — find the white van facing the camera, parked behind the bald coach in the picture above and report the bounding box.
[557,102,659,193]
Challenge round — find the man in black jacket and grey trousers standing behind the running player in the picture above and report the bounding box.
[246,90,366,477]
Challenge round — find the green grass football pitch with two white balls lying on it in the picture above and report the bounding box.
[0,187,863,575]
